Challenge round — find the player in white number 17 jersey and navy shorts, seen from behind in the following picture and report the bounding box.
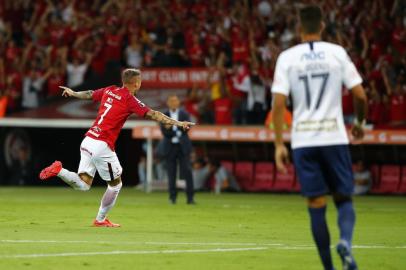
[272,5,367,270]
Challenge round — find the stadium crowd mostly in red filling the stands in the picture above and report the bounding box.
[0,0,406,127]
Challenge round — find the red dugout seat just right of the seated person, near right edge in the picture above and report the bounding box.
[373,165,400,194]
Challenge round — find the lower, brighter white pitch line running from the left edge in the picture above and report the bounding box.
[0,247,268,258]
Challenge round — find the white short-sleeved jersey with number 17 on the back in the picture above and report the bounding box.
[272,41,362,148]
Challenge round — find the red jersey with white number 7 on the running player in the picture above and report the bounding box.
[86,86,150,151]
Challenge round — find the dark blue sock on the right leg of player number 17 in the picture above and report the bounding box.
[336,200,355,247]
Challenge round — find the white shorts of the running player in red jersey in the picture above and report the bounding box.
[78,137,123,181]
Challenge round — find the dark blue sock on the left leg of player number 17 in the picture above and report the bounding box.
[309,207,334,270]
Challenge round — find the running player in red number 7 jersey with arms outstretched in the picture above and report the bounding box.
[40,69,194,227]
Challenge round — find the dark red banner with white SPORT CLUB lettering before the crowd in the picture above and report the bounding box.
[141,68,217,89]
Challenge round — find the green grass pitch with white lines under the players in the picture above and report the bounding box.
[0,187,406,270]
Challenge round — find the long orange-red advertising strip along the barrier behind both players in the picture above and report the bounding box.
[133,125,406,145]
